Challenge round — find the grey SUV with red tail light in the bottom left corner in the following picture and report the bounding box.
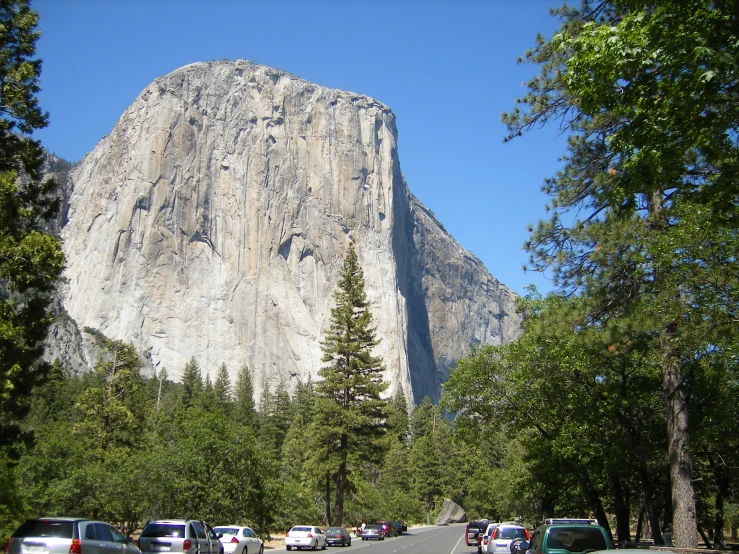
[5,517,141,554]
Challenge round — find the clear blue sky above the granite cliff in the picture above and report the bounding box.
[31,0,565,293]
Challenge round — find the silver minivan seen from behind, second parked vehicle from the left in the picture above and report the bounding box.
[138,519,224,554]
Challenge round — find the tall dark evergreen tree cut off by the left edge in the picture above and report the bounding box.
[0,0,64,450]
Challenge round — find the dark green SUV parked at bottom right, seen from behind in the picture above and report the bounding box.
[521,523,614,554]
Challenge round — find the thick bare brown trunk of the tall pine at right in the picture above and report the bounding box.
[660,323,698,548]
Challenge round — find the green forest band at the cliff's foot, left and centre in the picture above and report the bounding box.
[0,330,516,535]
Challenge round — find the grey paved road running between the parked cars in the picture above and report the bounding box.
[265,525,477,554]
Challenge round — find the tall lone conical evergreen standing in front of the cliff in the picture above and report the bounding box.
[312,245,388,525]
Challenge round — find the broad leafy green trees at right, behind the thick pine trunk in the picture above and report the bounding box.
[444,294,739,547]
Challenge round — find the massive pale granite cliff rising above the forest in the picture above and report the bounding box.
[56,60,521,402]
